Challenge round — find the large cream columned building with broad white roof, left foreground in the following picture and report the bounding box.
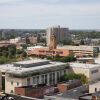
[0,59,67,93]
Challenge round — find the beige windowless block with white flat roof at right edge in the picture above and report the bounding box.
[69,62,100,82]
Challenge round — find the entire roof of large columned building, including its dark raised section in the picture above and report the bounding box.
[0,59,67,76]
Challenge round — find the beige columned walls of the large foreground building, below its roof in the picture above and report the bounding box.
[5,69,66,93]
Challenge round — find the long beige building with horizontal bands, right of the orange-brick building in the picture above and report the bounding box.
[57,45,99,57]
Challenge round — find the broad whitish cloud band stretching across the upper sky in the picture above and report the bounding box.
[0,4,100,17]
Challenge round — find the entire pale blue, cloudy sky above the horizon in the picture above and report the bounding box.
[0,0,100,29]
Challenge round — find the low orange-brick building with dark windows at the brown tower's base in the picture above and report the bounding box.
[27,46,73,57]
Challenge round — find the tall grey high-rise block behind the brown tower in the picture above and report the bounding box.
[46,25,70,46]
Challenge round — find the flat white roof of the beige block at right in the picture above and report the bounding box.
[69,62,100,69]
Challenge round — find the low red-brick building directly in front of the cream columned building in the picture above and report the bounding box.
[15,84,54,98]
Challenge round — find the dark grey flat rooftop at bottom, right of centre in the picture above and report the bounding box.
[45,85,88,100]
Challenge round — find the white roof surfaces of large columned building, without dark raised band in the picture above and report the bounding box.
[0,59,66,74]
